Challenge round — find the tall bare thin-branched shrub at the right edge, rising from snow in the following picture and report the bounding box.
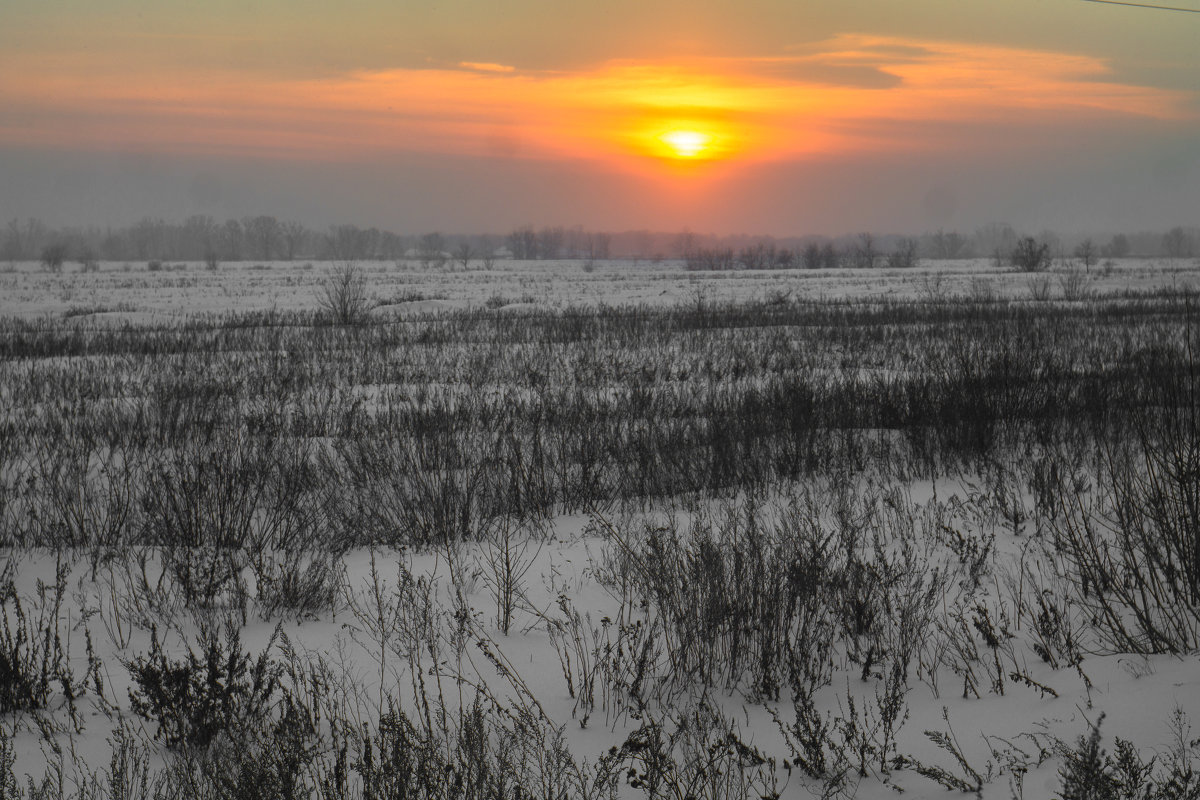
[1054,340,1200,652]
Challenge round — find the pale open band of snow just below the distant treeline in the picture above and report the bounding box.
[0,259,1200,324]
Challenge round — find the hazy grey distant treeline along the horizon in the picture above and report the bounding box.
[0,215,1200,263]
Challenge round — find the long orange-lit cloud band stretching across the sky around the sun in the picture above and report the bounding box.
[0,35,1195,169]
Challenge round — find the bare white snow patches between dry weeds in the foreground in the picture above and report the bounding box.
[6,486,1200,798]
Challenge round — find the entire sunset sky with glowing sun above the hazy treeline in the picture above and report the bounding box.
[0,0,1200,235]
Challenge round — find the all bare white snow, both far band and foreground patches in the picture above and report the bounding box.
[0,260,1200,798]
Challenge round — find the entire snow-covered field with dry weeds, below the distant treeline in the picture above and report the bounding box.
[0,259,1200,800]
